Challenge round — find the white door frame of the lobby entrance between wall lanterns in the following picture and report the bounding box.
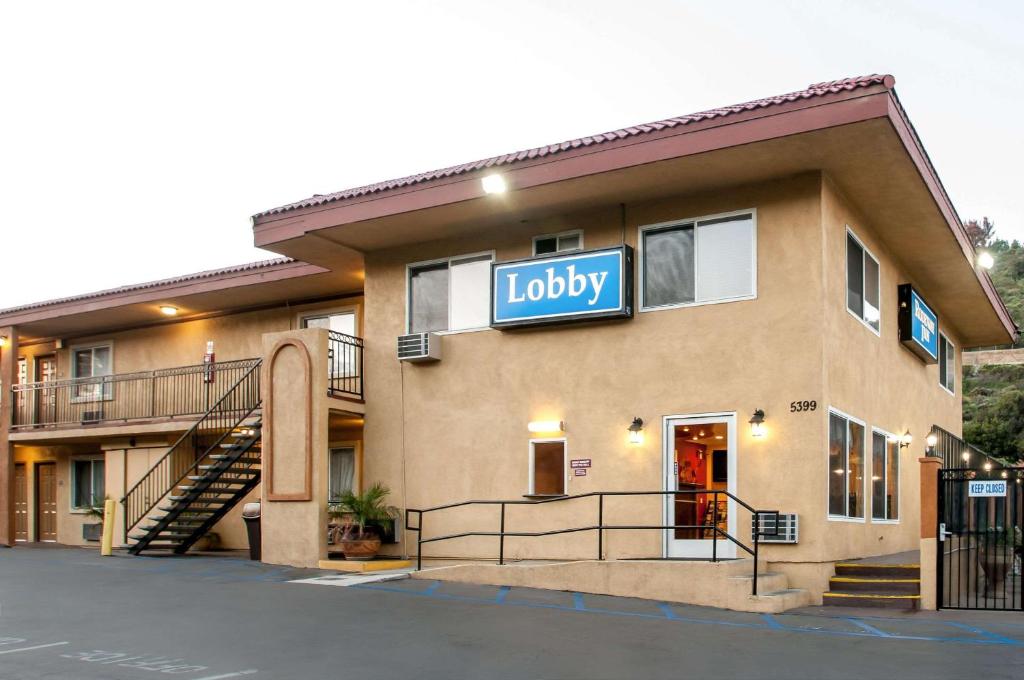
[662,411,739,559]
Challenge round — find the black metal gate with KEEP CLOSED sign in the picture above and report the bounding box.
[938,467,1024,611]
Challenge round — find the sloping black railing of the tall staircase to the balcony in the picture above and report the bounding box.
[121,359,262,538]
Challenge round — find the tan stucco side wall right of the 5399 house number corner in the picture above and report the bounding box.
[819,180,963,560]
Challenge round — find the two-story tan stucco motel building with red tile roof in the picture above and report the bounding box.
[0,76,1017,610]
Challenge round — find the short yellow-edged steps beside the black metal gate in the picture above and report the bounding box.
[821,561,921,609]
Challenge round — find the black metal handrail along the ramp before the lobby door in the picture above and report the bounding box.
[406,490,778,595]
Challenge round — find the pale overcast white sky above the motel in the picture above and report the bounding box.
[0,0,1024,308]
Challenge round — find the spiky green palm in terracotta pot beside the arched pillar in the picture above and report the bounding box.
[328,481,398,560]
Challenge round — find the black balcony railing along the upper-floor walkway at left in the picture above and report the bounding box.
[11,358,260,428]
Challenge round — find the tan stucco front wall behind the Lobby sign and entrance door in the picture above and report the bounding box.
[364,175,824,559]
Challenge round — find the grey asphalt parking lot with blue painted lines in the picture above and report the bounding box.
[0,548,1024,680]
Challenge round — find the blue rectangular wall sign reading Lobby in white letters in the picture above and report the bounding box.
[490,246,633,328]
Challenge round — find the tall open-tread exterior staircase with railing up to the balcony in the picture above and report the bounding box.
[121,363,262,555]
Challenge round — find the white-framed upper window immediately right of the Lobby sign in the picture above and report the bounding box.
[641,212,757,309]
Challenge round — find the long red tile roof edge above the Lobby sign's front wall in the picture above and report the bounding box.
[255,74,895,217]
